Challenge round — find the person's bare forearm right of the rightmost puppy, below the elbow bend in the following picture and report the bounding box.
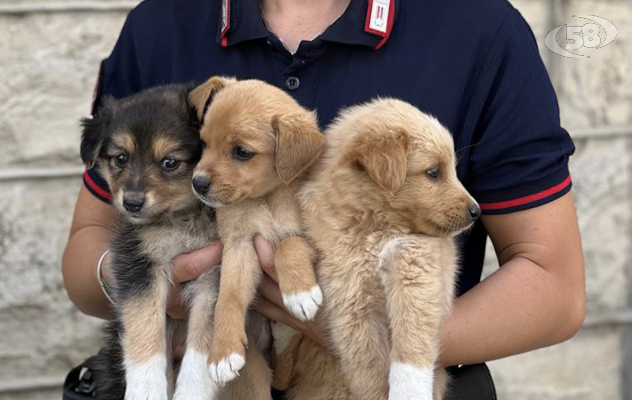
[439,257,584,366]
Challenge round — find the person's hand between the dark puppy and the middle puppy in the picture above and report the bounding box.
[167,240,222,319]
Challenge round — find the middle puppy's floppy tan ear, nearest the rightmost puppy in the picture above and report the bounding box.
[272,111,325,184]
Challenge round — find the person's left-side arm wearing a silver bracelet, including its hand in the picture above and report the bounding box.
[62,186,222,319]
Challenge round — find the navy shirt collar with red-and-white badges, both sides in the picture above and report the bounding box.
[216,0,400,49]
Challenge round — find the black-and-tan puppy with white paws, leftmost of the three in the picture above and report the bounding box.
[81,86,271,400]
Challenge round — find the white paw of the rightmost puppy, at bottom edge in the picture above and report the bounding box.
[388,362,434,400]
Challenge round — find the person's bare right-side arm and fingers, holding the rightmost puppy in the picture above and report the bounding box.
[257,193,585,366]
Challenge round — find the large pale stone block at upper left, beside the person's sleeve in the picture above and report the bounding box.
[0,13,124,168]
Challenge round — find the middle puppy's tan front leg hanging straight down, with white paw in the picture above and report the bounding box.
[210,238,261,385]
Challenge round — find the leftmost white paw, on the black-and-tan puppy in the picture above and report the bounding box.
[125,356,168,400]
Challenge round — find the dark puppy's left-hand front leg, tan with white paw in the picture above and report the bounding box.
[119,268,169,400]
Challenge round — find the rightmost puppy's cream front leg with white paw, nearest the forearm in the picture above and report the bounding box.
[380,238,455,400]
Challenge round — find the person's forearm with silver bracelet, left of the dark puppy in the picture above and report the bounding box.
[62,226,112,319]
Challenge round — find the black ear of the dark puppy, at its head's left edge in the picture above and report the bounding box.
[79,98,114,168]
